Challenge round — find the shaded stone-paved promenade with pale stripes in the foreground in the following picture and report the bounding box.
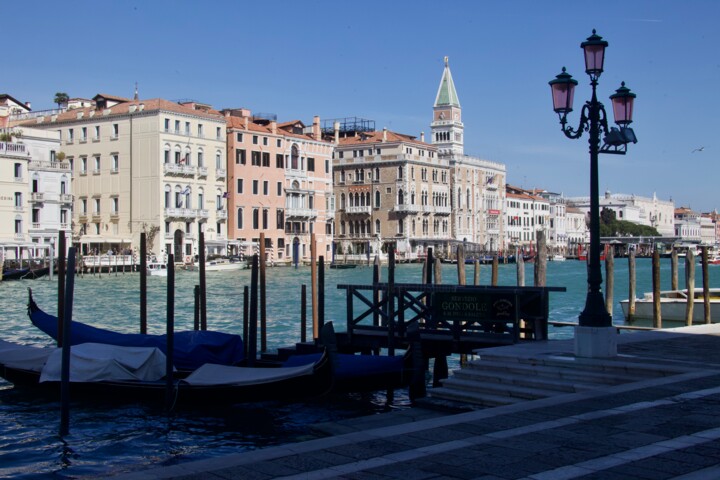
[116,325,720,480]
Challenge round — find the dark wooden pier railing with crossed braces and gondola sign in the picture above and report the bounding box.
[338,283,565,353]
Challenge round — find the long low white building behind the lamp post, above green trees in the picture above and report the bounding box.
[568,191,675,237]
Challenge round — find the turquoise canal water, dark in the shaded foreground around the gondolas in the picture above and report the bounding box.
[0,259,720,479]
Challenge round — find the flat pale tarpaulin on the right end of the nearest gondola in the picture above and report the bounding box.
[184,363,315,385]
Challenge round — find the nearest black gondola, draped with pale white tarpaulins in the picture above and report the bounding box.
[0,340,333,407]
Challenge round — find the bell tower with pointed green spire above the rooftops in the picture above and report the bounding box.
[430,57,465,155]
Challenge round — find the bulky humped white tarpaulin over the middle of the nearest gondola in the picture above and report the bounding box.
[40,343,166,382]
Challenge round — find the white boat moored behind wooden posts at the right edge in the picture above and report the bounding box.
[620,288,720,326]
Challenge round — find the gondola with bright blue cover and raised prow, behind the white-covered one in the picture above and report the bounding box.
[28,288,245,371]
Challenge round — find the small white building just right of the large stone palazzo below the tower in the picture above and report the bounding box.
[505,185,554,252]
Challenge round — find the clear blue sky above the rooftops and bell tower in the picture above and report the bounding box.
[7,0,720,212]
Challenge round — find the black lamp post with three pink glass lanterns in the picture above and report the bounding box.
[550,30,637,327]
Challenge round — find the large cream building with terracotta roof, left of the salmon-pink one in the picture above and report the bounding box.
[21,92,228,261]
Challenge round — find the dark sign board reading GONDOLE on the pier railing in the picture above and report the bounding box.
[432,292,516,322]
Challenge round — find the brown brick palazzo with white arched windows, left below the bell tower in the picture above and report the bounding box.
[332,122,444,259]
